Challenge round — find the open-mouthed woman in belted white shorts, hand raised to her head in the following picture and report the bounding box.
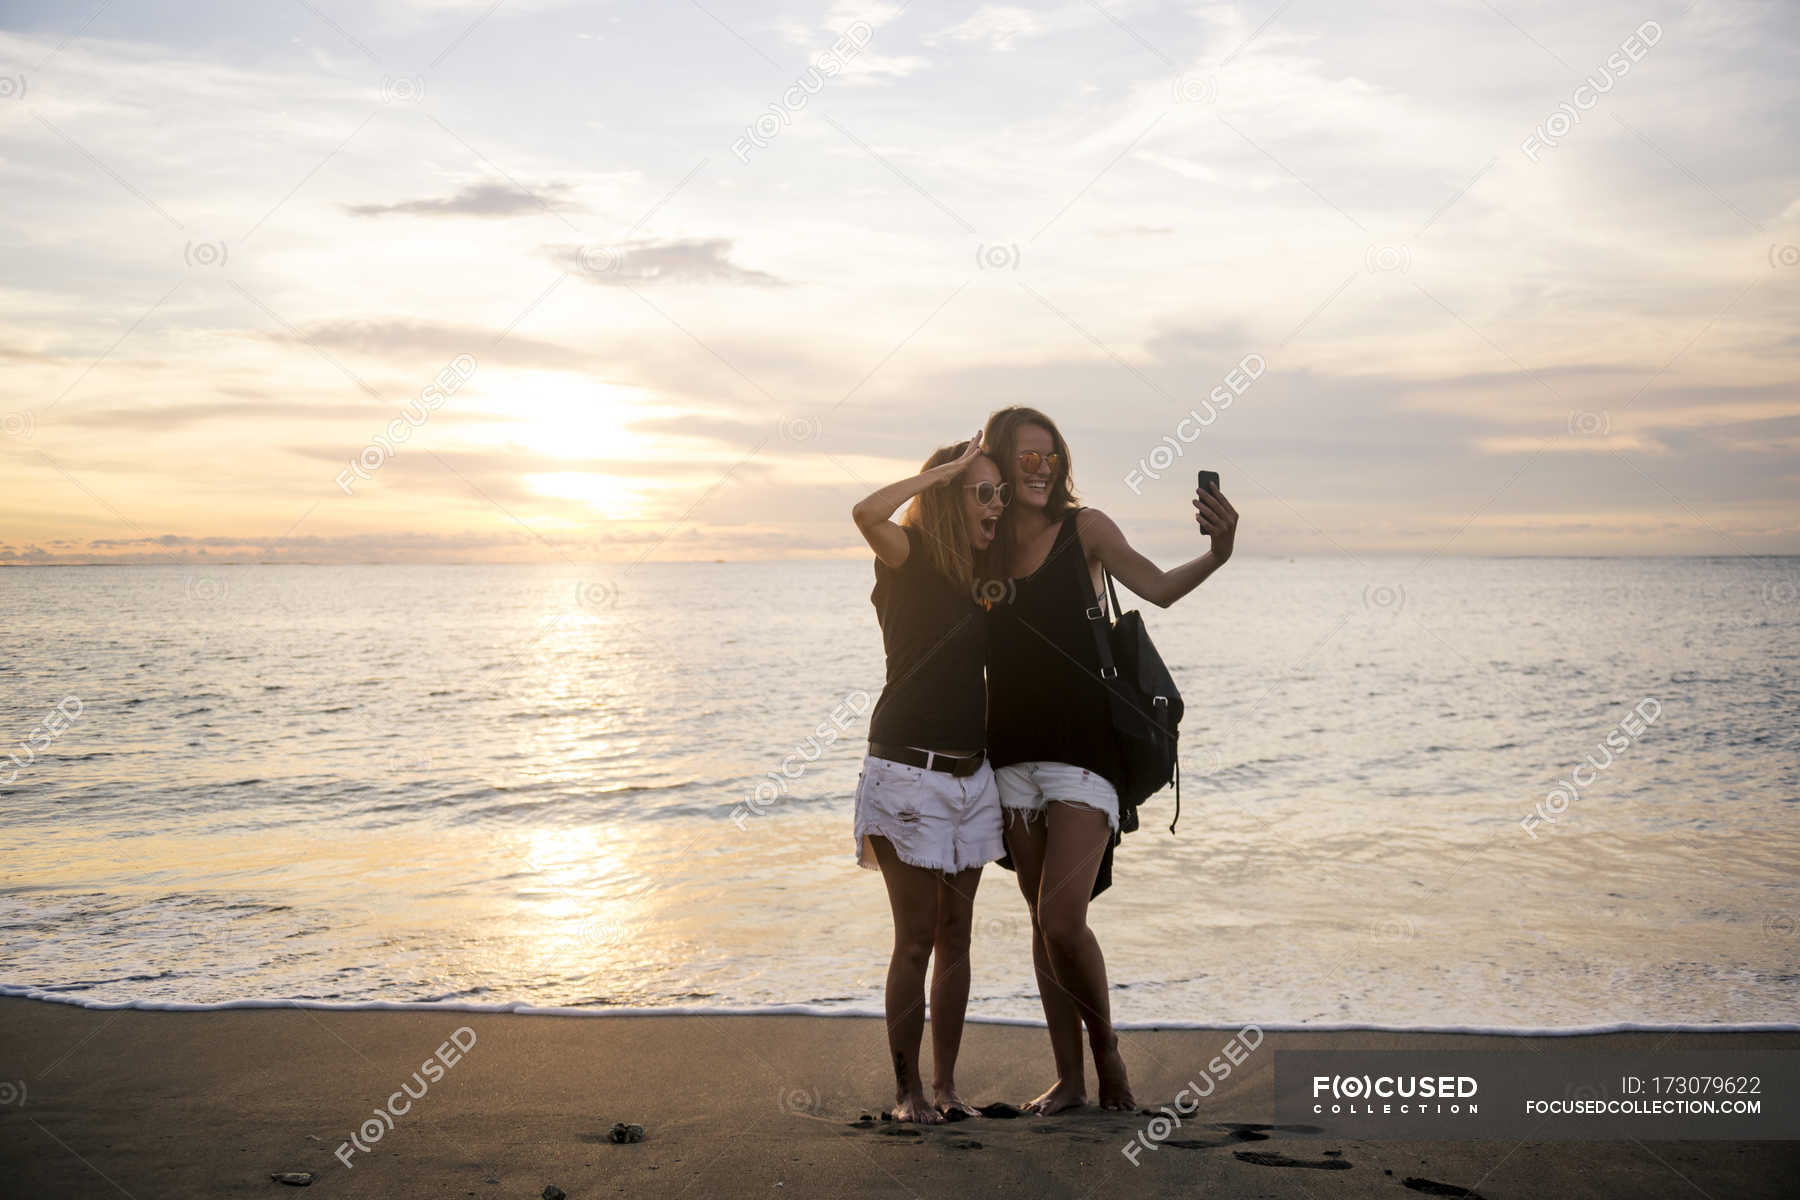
[851,437,1010,1124]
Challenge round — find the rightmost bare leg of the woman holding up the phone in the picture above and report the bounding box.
[1037,801,1136,1110]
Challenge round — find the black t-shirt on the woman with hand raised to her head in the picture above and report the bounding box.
[869,525,988,750]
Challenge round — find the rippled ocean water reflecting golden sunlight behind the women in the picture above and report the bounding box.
[0,556,1800,1029]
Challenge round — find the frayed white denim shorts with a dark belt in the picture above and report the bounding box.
[855,754,1006,873]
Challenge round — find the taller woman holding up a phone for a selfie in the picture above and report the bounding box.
[983,408,1237,1114]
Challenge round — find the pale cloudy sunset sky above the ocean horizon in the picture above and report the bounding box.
[0,0,1800,563]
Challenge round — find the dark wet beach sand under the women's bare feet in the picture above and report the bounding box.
[0,999,1800,1200]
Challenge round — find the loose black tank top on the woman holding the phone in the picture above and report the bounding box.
[988,513,1123,788]
